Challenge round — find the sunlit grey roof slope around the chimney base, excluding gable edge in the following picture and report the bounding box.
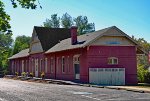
[45,26,114,53]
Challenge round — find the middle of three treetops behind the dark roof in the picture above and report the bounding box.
[61,13,73,28]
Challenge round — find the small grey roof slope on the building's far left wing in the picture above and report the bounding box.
[8,48,29,59]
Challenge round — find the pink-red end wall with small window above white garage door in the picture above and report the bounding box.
[87,46,137,84]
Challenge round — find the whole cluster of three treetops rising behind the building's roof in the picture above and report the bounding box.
[43,13,95,35]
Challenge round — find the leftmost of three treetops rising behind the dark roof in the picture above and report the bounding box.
[43,14,60,28]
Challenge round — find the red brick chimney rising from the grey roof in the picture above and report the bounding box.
[70,26,78,45]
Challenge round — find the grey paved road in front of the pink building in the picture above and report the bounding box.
[0,78,150,101]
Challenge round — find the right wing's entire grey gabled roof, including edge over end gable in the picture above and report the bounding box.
[45,26,144,53]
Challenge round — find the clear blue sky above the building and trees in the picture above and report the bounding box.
[2,0,150,42]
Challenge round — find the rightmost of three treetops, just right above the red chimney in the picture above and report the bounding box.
[74,16,95,35]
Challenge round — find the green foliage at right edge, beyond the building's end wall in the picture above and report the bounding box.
[132,36,150,83]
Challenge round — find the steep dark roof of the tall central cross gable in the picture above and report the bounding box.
[34,26,71,51]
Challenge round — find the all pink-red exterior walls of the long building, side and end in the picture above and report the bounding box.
[11,46,137,84]
